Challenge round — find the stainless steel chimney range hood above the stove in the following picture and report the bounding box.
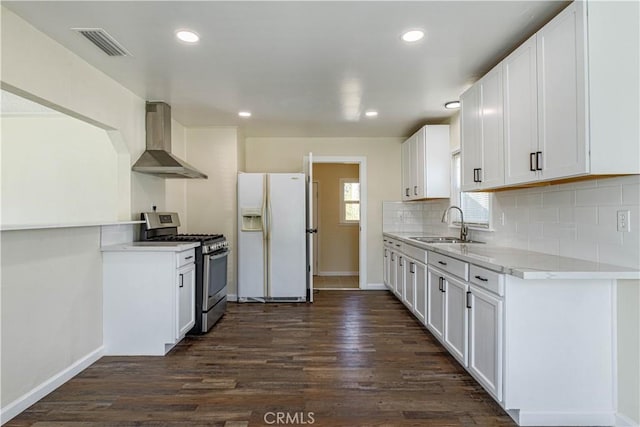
[132,102,207,179]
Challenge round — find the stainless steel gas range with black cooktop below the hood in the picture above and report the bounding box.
[140,212,230,334]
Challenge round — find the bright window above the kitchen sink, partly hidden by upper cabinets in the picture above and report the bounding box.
[450,151,491,229]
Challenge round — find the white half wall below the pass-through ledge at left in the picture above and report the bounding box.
[0,227,102,410]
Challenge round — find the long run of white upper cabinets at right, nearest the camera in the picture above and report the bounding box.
[461,1,640,190]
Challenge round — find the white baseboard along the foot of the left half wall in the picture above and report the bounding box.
[0,346,104,424]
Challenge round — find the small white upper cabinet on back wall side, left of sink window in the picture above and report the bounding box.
[402,125,451,200]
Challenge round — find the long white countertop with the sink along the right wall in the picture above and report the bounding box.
[383,232,640,279]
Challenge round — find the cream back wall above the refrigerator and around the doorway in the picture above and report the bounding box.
[246,138,404,285]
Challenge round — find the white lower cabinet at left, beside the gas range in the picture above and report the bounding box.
[103,248,195,356]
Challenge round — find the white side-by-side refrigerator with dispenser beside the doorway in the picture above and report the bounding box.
[238,173,307,302]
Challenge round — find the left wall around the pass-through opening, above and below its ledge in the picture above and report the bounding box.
[0,8,165,421]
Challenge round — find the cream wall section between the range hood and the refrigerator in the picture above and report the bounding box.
[185,127,239,295]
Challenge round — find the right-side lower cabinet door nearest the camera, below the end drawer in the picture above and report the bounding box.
[467,285,503,401]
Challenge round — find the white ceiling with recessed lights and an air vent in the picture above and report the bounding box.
[2,0,567,136]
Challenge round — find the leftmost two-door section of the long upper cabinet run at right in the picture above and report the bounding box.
[461,64,504,191]
